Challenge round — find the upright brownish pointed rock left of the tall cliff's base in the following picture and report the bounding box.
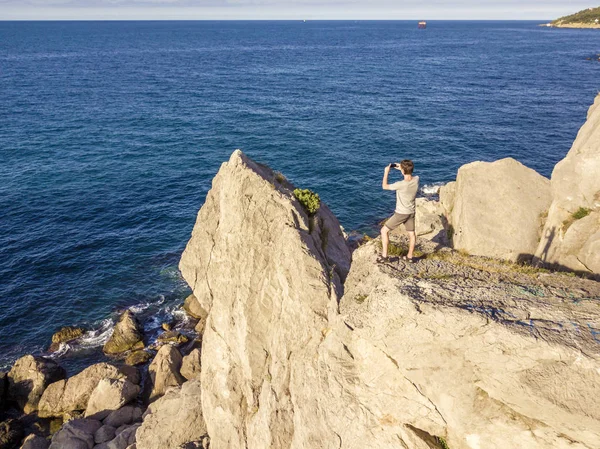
[146,345,185,402]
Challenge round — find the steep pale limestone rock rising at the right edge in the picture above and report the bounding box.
[536,95,600,274]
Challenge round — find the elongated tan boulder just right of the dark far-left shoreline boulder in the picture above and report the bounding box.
[39,363,124,418]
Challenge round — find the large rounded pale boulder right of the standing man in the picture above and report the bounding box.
[442,158,551,261]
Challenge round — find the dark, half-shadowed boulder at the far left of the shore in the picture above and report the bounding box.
[8,355,66,413]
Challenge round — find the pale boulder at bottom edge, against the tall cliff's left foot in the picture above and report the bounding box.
[136,380,207,449]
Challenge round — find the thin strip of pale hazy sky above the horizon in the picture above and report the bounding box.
[0,0,597,20]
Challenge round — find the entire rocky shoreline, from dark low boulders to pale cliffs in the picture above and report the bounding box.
[0,96,600,449]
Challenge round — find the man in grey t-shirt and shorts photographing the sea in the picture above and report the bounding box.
[377,159,419,262]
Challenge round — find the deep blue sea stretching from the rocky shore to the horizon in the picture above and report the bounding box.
[0,21,600,373]
